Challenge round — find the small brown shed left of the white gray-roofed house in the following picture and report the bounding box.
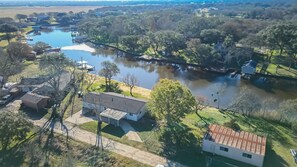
[21,92,50,112]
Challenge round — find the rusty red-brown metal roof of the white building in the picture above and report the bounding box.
[204,124,266,155]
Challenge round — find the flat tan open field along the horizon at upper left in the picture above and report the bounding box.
[0,6,100,18]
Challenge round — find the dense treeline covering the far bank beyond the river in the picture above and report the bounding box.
[78,5,297,68]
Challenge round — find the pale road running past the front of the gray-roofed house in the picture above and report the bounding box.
[31,118,184,167]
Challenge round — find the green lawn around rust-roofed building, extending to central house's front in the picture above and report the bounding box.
[80,108,297,167]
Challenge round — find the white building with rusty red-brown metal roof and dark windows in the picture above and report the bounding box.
[202,124,266,167]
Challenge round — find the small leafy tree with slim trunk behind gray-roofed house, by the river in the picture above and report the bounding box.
[99,61,120,91]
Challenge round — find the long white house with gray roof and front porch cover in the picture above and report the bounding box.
[82,92,147,126]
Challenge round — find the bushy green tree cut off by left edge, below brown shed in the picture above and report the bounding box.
[0,111,32,150]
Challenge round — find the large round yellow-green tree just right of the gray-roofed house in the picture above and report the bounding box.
[148,79,196,126]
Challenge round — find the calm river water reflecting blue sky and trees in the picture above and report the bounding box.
[29,26,297,106]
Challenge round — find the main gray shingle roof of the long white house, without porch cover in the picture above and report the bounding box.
[84,92,147,114]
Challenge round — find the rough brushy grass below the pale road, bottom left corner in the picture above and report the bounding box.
[0,130,148,167]
